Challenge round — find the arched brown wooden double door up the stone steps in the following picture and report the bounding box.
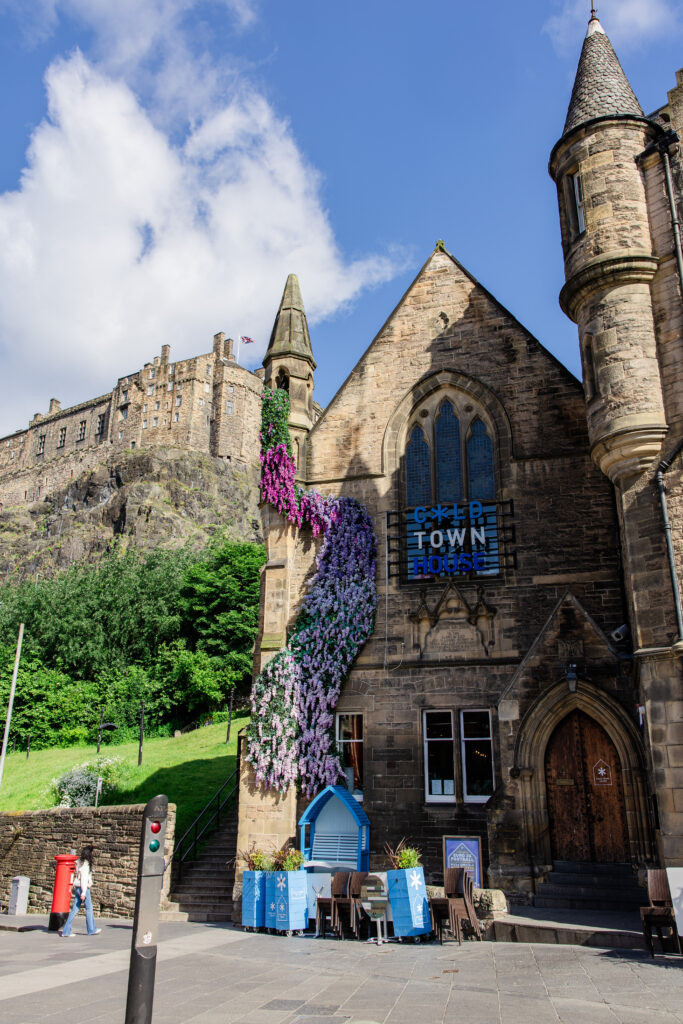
[546,710,630,862]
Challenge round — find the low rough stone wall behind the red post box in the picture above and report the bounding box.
[0,804,175,918]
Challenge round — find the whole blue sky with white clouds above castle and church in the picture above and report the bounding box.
[0,0,683,435]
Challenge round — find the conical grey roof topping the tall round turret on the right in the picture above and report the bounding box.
[563,13,644,135]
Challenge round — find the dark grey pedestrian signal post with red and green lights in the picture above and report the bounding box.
[126,796,168,1024]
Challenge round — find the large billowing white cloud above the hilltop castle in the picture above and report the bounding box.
[0,52,397,434]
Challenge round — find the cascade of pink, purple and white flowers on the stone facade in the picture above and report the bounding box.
[247,389,377,797]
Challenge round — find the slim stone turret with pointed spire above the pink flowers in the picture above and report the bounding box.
[263,273,315,472]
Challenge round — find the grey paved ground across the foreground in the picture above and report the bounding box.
[0,918,683,1024]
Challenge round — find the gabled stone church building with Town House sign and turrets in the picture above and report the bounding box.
[238,15,683,899]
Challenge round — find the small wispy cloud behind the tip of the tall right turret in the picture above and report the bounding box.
[544,0,680,54]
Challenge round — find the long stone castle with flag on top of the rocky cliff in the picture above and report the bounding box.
[0,333,262,509]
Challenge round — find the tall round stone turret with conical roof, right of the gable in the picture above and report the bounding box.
[550,14,667,486]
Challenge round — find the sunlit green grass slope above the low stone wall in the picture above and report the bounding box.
[0,718,249,839]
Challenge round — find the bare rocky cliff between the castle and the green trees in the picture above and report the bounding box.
[0,447,261,581]
